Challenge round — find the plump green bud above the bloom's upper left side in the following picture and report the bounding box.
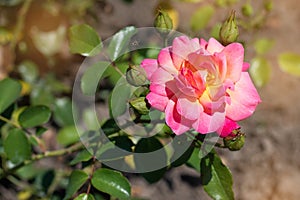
[154,10,173,34]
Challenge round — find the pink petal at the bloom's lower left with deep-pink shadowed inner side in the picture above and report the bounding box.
[165,100,192,135]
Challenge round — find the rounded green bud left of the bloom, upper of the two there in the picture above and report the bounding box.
[126,65,147,87]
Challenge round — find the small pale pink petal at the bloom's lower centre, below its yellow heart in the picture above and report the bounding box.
[176,96,203,120]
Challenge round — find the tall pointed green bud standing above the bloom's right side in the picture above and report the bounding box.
[219,11,239,45]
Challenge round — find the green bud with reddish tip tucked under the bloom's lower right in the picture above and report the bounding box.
[223,129,245,151]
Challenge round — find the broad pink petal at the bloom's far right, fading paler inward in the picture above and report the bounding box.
[226,72,261,121]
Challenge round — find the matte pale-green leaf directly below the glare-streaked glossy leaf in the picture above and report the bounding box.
[81,62,110,95]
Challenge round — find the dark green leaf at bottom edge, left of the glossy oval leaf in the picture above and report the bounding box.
[64,170,89,199]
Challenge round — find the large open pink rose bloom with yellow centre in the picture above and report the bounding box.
[141,36,261,137]
